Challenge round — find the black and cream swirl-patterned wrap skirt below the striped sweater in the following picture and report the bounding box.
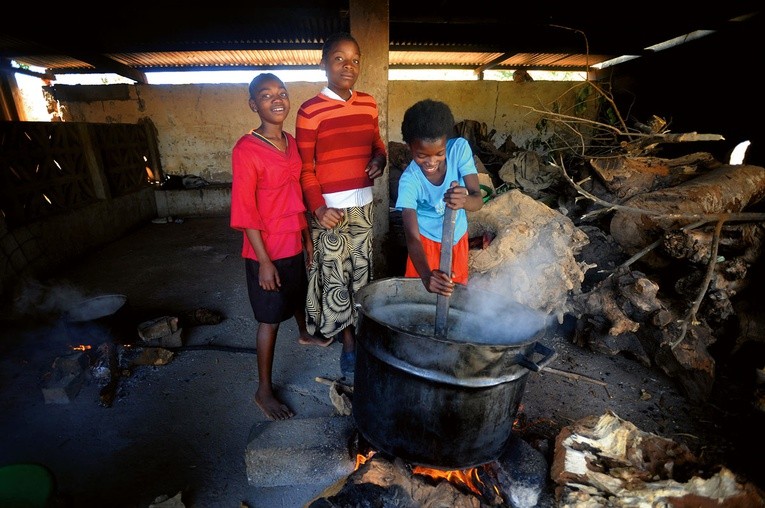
[306,203,374,337]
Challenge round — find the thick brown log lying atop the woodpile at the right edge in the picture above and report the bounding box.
[610,165,765,268]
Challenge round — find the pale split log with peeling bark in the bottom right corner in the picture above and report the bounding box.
[550,412,765,508]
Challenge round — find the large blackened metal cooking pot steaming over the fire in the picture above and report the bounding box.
[353,277,556,469]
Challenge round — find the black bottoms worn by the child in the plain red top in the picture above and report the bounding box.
[244,252,308,324]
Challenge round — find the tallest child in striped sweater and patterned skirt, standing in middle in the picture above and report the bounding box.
[295,33,387,377]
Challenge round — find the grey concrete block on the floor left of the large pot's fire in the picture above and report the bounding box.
[245,416,356,487]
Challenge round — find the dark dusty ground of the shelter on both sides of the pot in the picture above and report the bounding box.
[0,217,765,508]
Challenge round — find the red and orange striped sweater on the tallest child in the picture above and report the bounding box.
[295,91,387,212]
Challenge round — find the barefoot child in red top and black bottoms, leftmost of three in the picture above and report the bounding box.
[231,73,331,420]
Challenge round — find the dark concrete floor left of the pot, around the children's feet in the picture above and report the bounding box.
[0,218,348,508]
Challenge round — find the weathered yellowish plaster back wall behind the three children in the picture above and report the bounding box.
[54,79,583,182]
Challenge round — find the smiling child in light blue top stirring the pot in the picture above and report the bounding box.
[396,99,483,296]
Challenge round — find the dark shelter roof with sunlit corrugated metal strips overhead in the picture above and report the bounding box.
[0,0,759,79]
